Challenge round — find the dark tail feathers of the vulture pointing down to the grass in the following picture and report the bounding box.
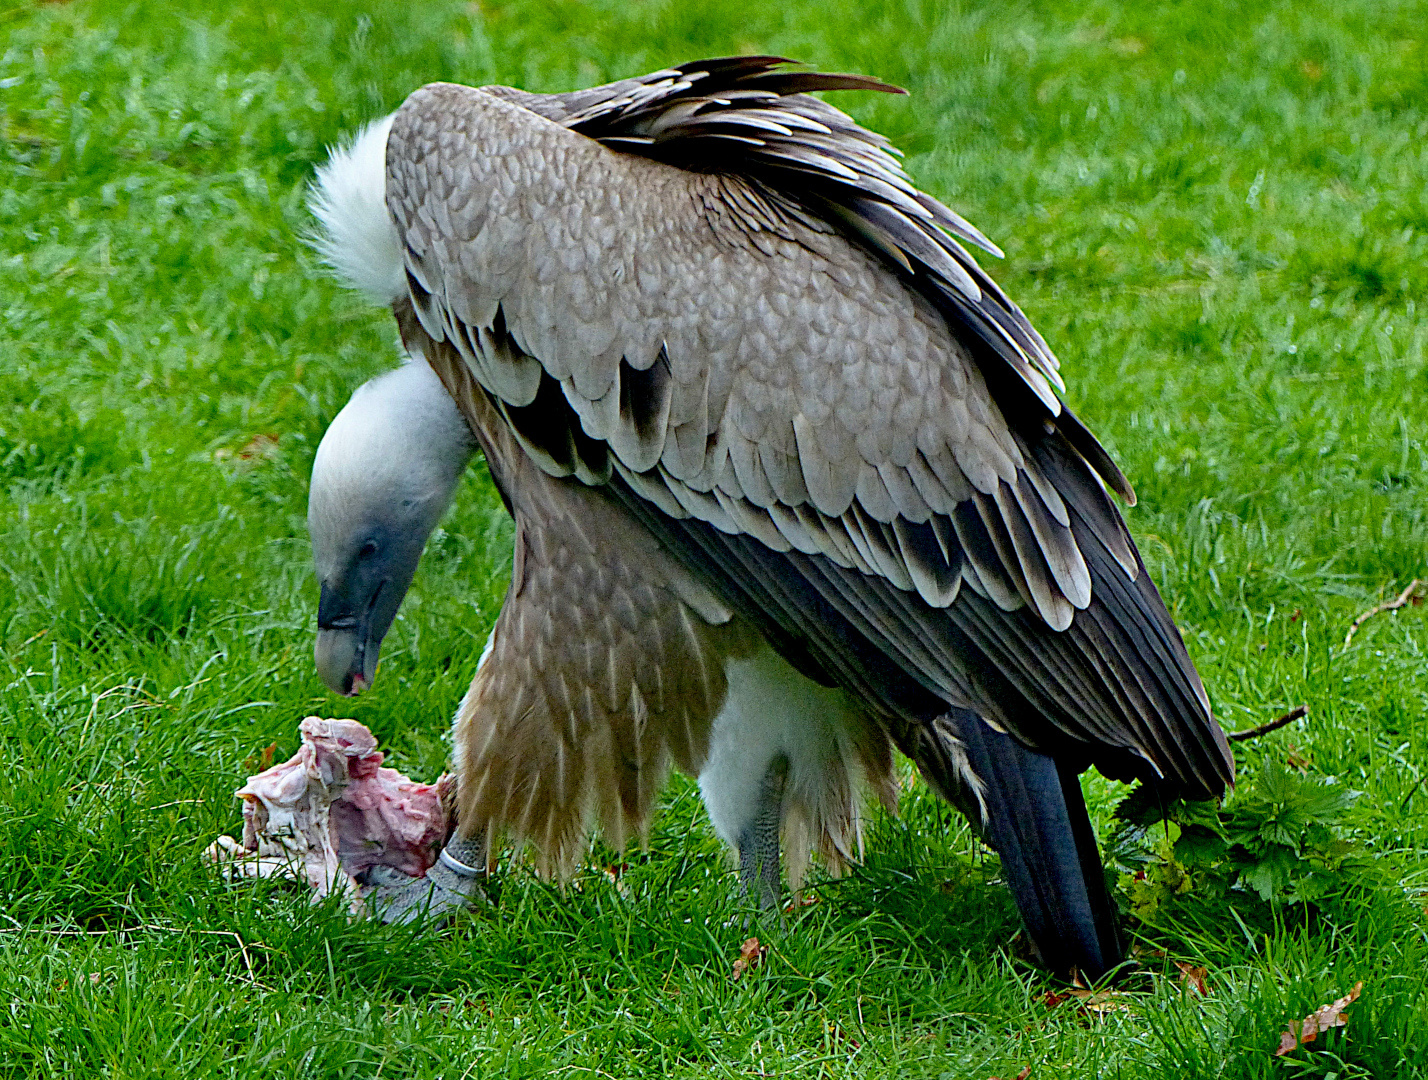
[951,710,1122,981]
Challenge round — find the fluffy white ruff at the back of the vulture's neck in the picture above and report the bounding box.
[308,114,407,306]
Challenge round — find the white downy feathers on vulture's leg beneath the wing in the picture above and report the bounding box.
[700,644,865,860]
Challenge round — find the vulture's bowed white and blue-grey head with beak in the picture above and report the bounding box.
[307,360,476,696]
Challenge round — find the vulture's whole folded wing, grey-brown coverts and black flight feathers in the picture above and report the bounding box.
[387,57,1232,794]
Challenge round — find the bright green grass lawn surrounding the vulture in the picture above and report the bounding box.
[0,0,1428,1080]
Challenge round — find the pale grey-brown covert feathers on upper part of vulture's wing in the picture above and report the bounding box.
[388,84,1087,626]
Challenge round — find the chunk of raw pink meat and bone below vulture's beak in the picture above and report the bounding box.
[208,716,451,910]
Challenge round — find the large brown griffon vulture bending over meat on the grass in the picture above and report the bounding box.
[310,56,1234,979]
